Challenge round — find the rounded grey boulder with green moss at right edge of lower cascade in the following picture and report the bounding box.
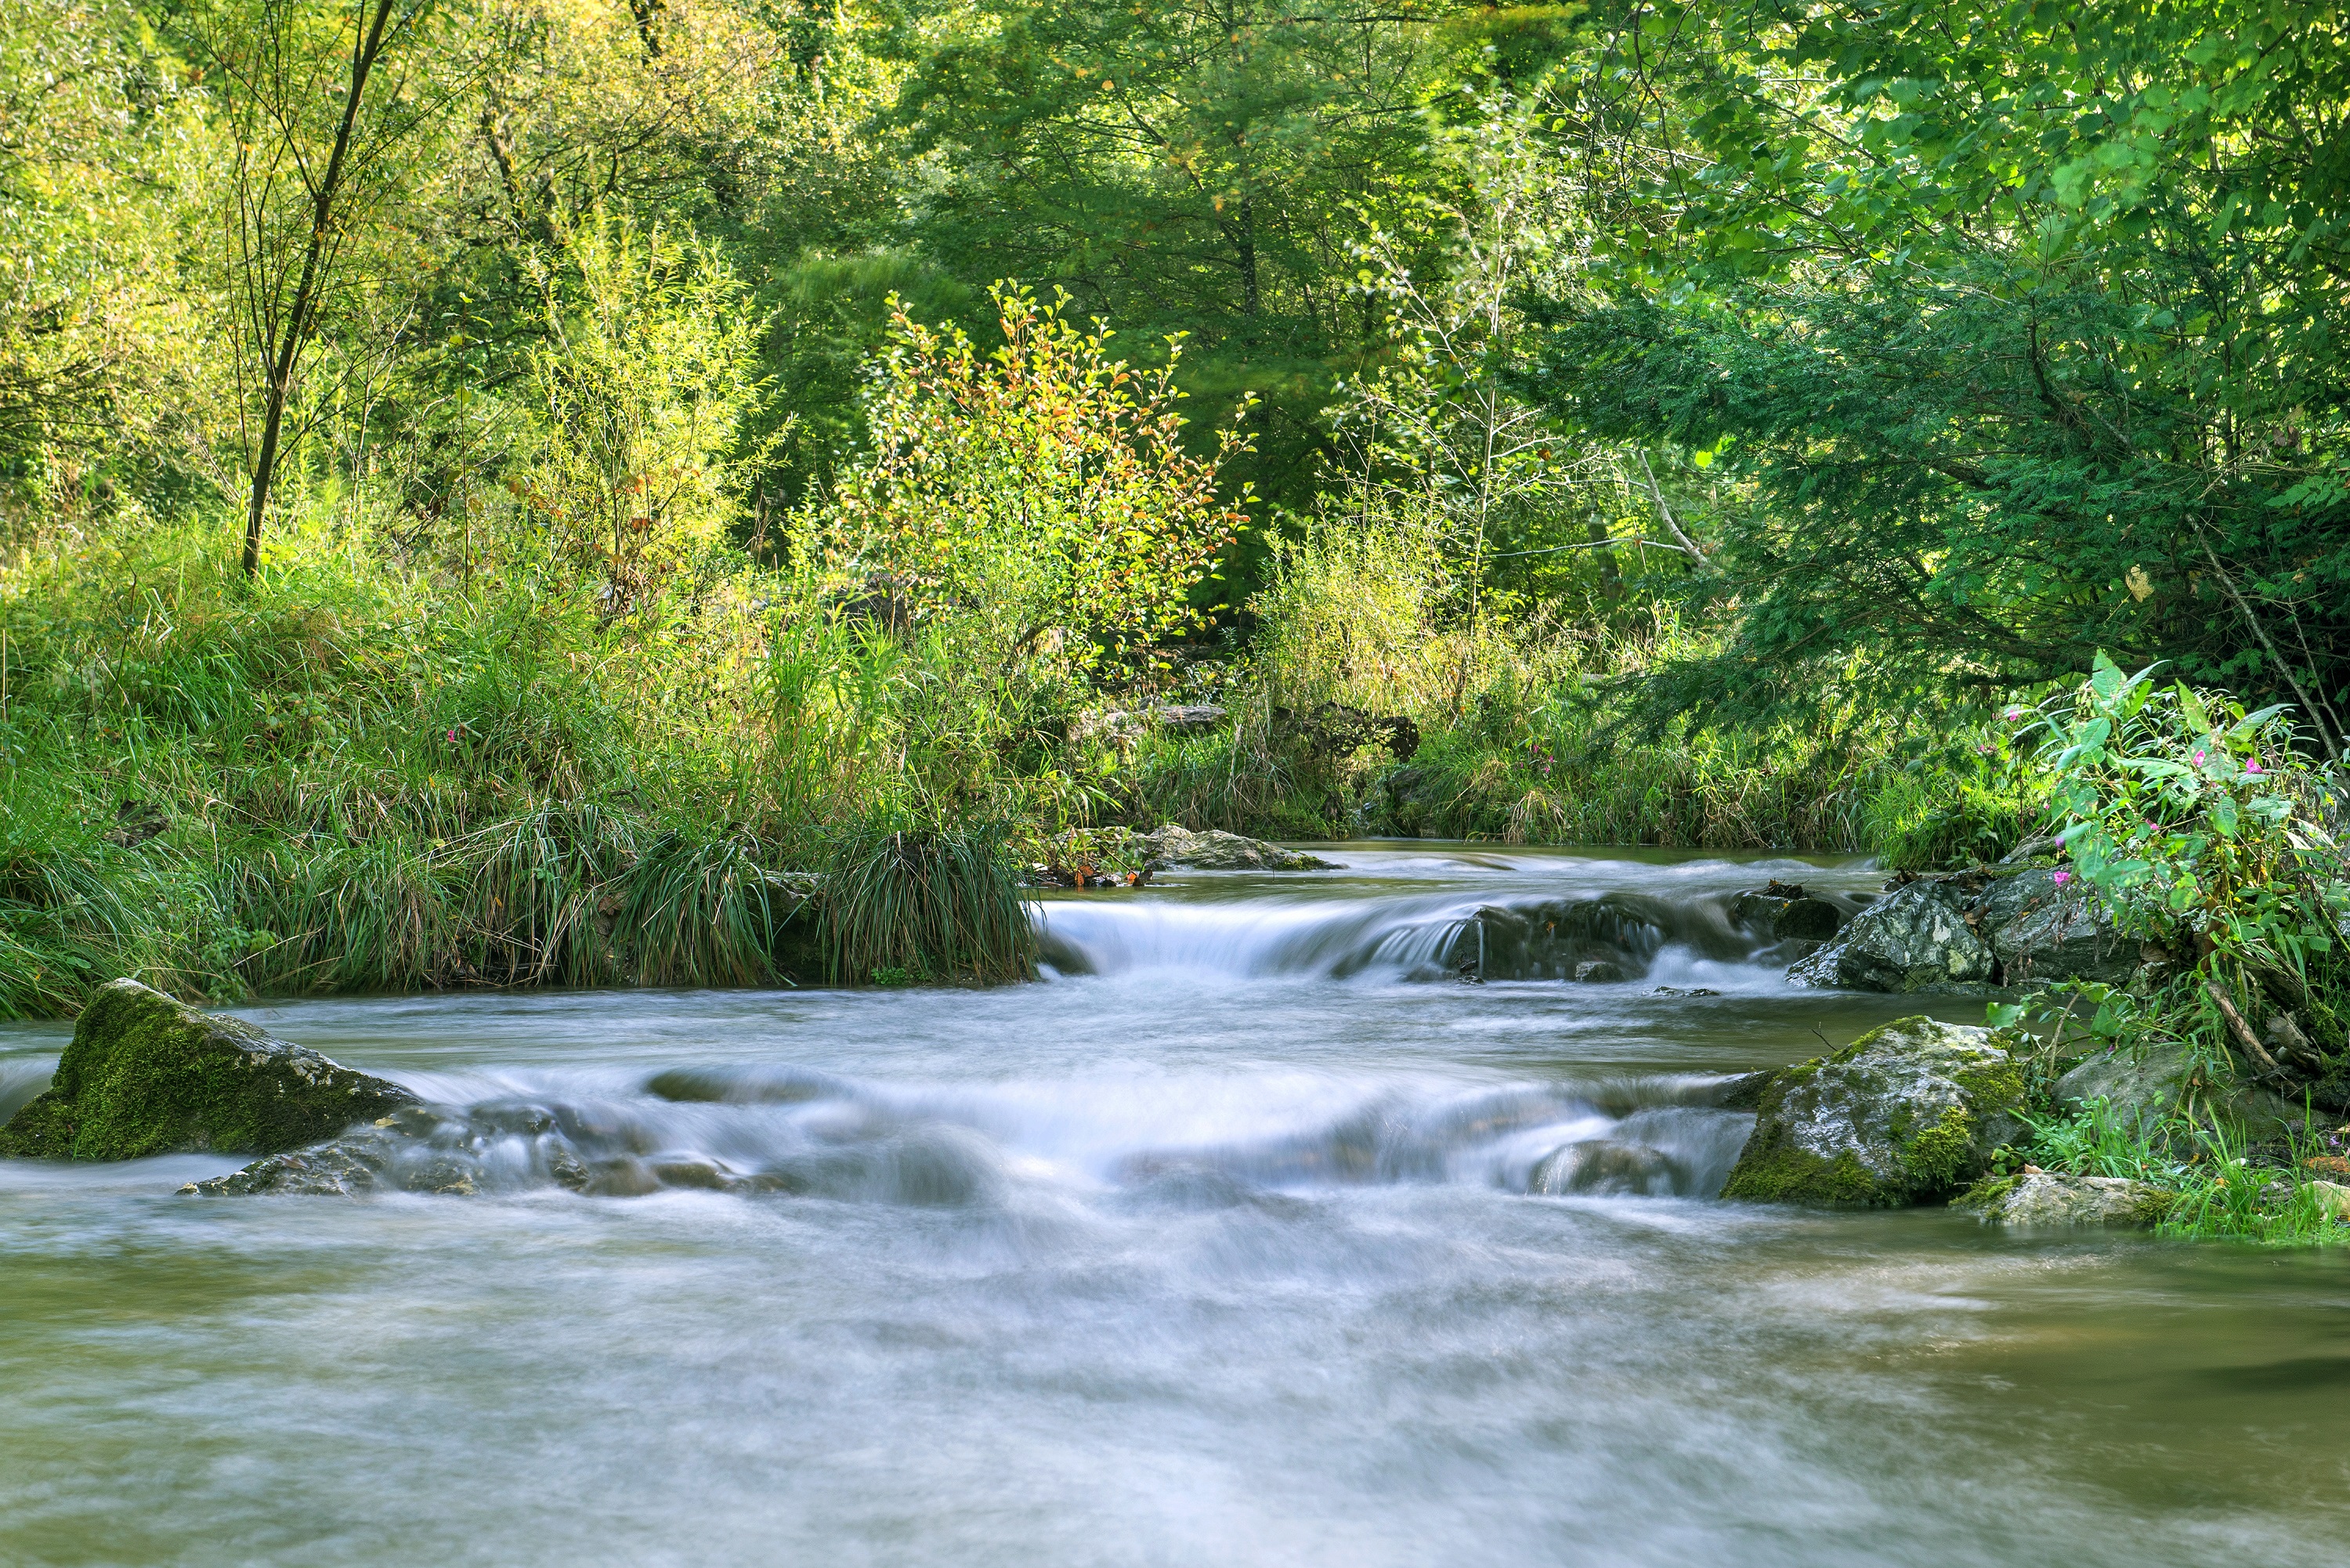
[1723,1018,2023,1209]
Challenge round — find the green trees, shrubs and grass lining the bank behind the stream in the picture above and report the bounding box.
[0,0,2350,1053]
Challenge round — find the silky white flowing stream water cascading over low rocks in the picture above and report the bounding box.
[0,844,2350,1568]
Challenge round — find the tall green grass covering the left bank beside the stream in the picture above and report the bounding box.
[0,533,1034,1018]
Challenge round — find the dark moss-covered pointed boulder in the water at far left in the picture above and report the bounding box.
[0,981,416,1159]
